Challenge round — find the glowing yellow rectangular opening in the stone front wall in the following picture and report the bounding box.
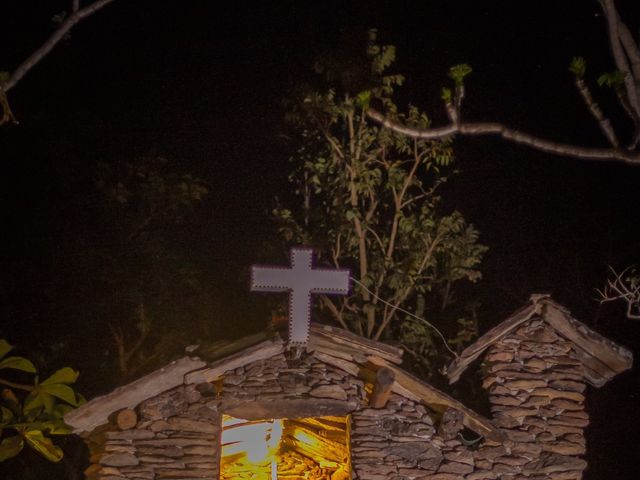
[220,415,351,480]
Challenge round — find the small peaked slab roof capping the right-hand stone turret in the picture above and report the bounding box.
[447,295,633,387]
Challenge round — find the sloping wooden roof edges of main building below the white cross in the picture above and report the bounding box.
[65,324,502,442]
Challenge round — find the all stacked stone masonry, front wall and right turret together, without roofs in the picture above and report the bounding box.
[86,318,588,480]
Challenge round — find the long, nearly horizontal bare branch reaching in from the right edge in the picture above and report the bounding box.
[367,108,640,165]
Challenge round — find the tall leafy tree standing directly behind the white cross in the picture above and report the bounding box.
[273,31,486,372]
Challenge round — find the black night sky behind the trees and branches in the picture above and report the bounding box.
[0,0,640,479]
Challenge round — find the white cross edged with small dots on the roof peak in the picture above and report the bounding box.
[251,248,349,346]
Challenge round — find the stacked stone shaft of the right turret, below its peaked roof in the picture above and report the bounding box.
[474,318,589,480]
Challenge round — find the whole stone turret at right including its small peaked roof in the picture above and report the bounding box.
[449,295,632,480]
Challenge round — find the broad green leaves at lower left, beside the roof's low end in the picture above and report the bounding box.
[0,339,84,462]
